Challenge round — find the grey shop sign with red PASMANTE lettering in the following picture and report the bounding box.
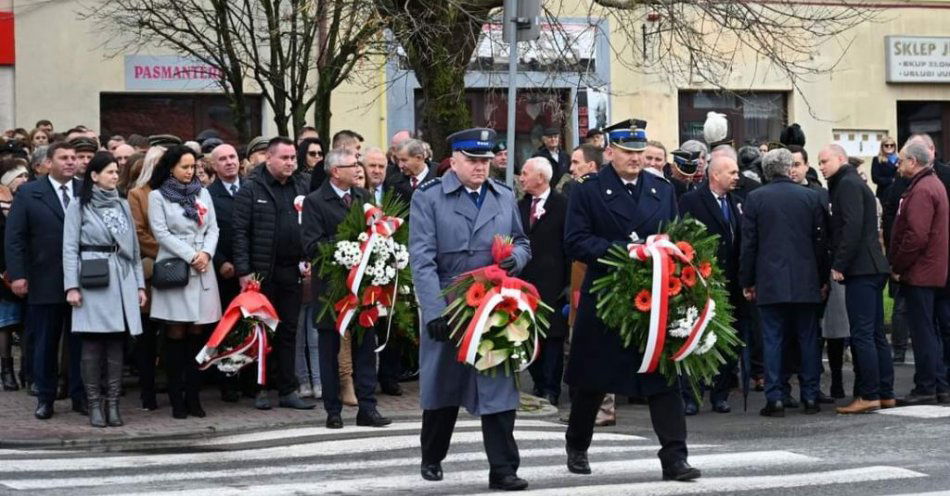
[125,55,220,91]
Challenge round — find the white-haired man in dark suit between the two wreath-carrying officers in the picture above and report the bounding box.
[518,157,570,406]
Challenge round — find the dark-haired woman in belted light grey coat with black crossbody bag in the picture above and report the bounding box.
[63,152,147,427]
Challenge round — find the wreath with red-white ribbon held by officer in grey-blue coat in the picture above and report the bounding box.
[443,236,552,375]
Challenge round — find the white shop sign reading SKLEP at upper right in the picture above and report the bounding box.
[884,36,950,83]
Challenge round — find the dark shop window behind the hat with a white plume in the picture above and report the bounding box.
[680,91,788,146]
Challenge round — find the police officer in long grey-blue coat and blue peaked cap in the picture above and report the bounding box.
[409,129,531,490]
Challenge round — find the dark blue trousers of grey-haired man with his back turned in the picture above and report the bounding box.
[759,303,821,402]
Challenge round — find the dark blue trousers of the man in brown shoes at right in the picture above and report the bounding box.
[844,274,894,401]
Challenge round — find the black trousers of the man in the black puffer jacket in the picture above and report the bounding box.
[261,265,301,396]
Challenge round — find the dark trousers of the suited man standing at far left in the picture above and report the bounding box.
[26,303,86,403]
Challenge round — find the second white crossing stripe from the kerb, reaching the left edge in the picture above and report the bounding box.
[0,430,643,475]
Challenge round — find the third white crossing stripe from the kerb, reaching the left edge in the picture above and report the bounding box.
[0,444,715,490]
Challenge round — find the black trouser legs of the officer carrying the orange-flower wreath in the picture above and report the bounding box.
[566,389,688,468]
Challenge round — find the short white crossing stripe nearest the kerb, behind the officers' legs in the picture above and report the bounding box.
[191,420,588,447]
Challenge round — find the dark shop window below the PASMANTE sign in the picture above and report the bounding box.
[99,93,261,143]
